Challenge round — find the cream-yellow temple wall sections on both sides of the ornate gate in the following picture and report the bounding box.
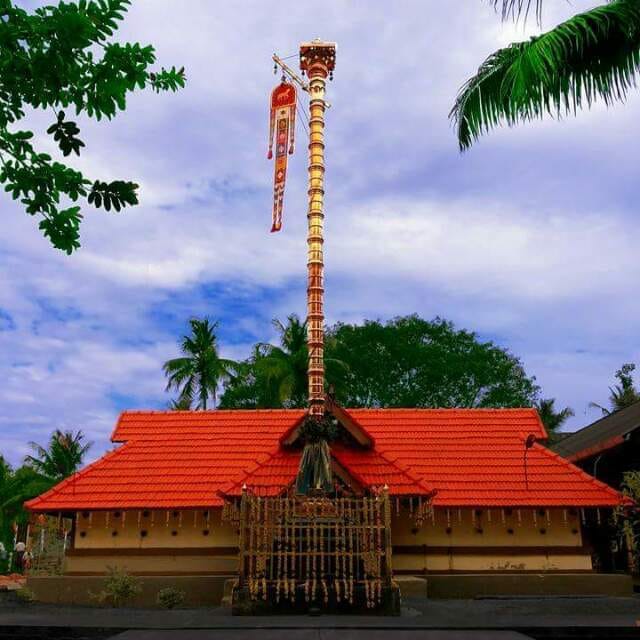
[65,504,592,574]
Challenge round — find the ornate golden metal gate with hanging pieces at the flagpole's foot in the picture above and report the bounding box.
[227,491,392,609]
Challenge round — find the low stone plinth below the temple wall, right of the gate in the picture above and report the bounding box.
[418,573,633,599]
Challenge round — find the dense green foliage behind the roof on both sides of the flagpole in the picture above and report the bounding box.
[220,316,538,409]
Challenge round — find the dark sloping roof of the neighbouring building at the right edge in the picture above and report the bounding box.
[551,402,640,462]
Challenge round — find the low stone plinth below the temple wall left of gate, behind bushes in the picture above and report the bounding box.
[27,575,233,607]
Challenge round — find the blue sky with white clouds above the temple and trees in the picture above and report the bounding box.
[0,0,640,463]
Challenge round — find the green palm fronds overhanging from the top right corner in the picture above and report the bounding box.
[450,0,640,150]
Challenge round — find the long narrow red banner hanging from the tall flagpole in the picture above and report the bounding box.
[267,81,296,232]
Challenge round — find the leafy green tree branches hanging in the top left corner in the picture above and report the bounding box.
[0,0,185,253]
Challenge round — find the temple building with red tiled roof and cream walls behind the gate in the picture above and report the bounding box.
[28,400,632,595]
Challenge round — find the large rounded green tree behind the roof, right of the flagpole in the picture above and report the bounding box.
[326,315,538,407]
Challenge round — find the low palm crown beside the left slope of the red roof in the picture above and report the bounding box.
[24,429,93,480]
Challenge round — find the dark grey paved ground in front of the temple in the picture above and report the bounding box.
[0,597,640,640]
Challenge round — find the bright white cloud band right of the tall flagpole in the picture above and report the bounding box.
[330,197,639,304]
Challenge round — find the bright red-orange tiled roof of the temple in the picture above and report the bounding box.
[27,409,621,511]
